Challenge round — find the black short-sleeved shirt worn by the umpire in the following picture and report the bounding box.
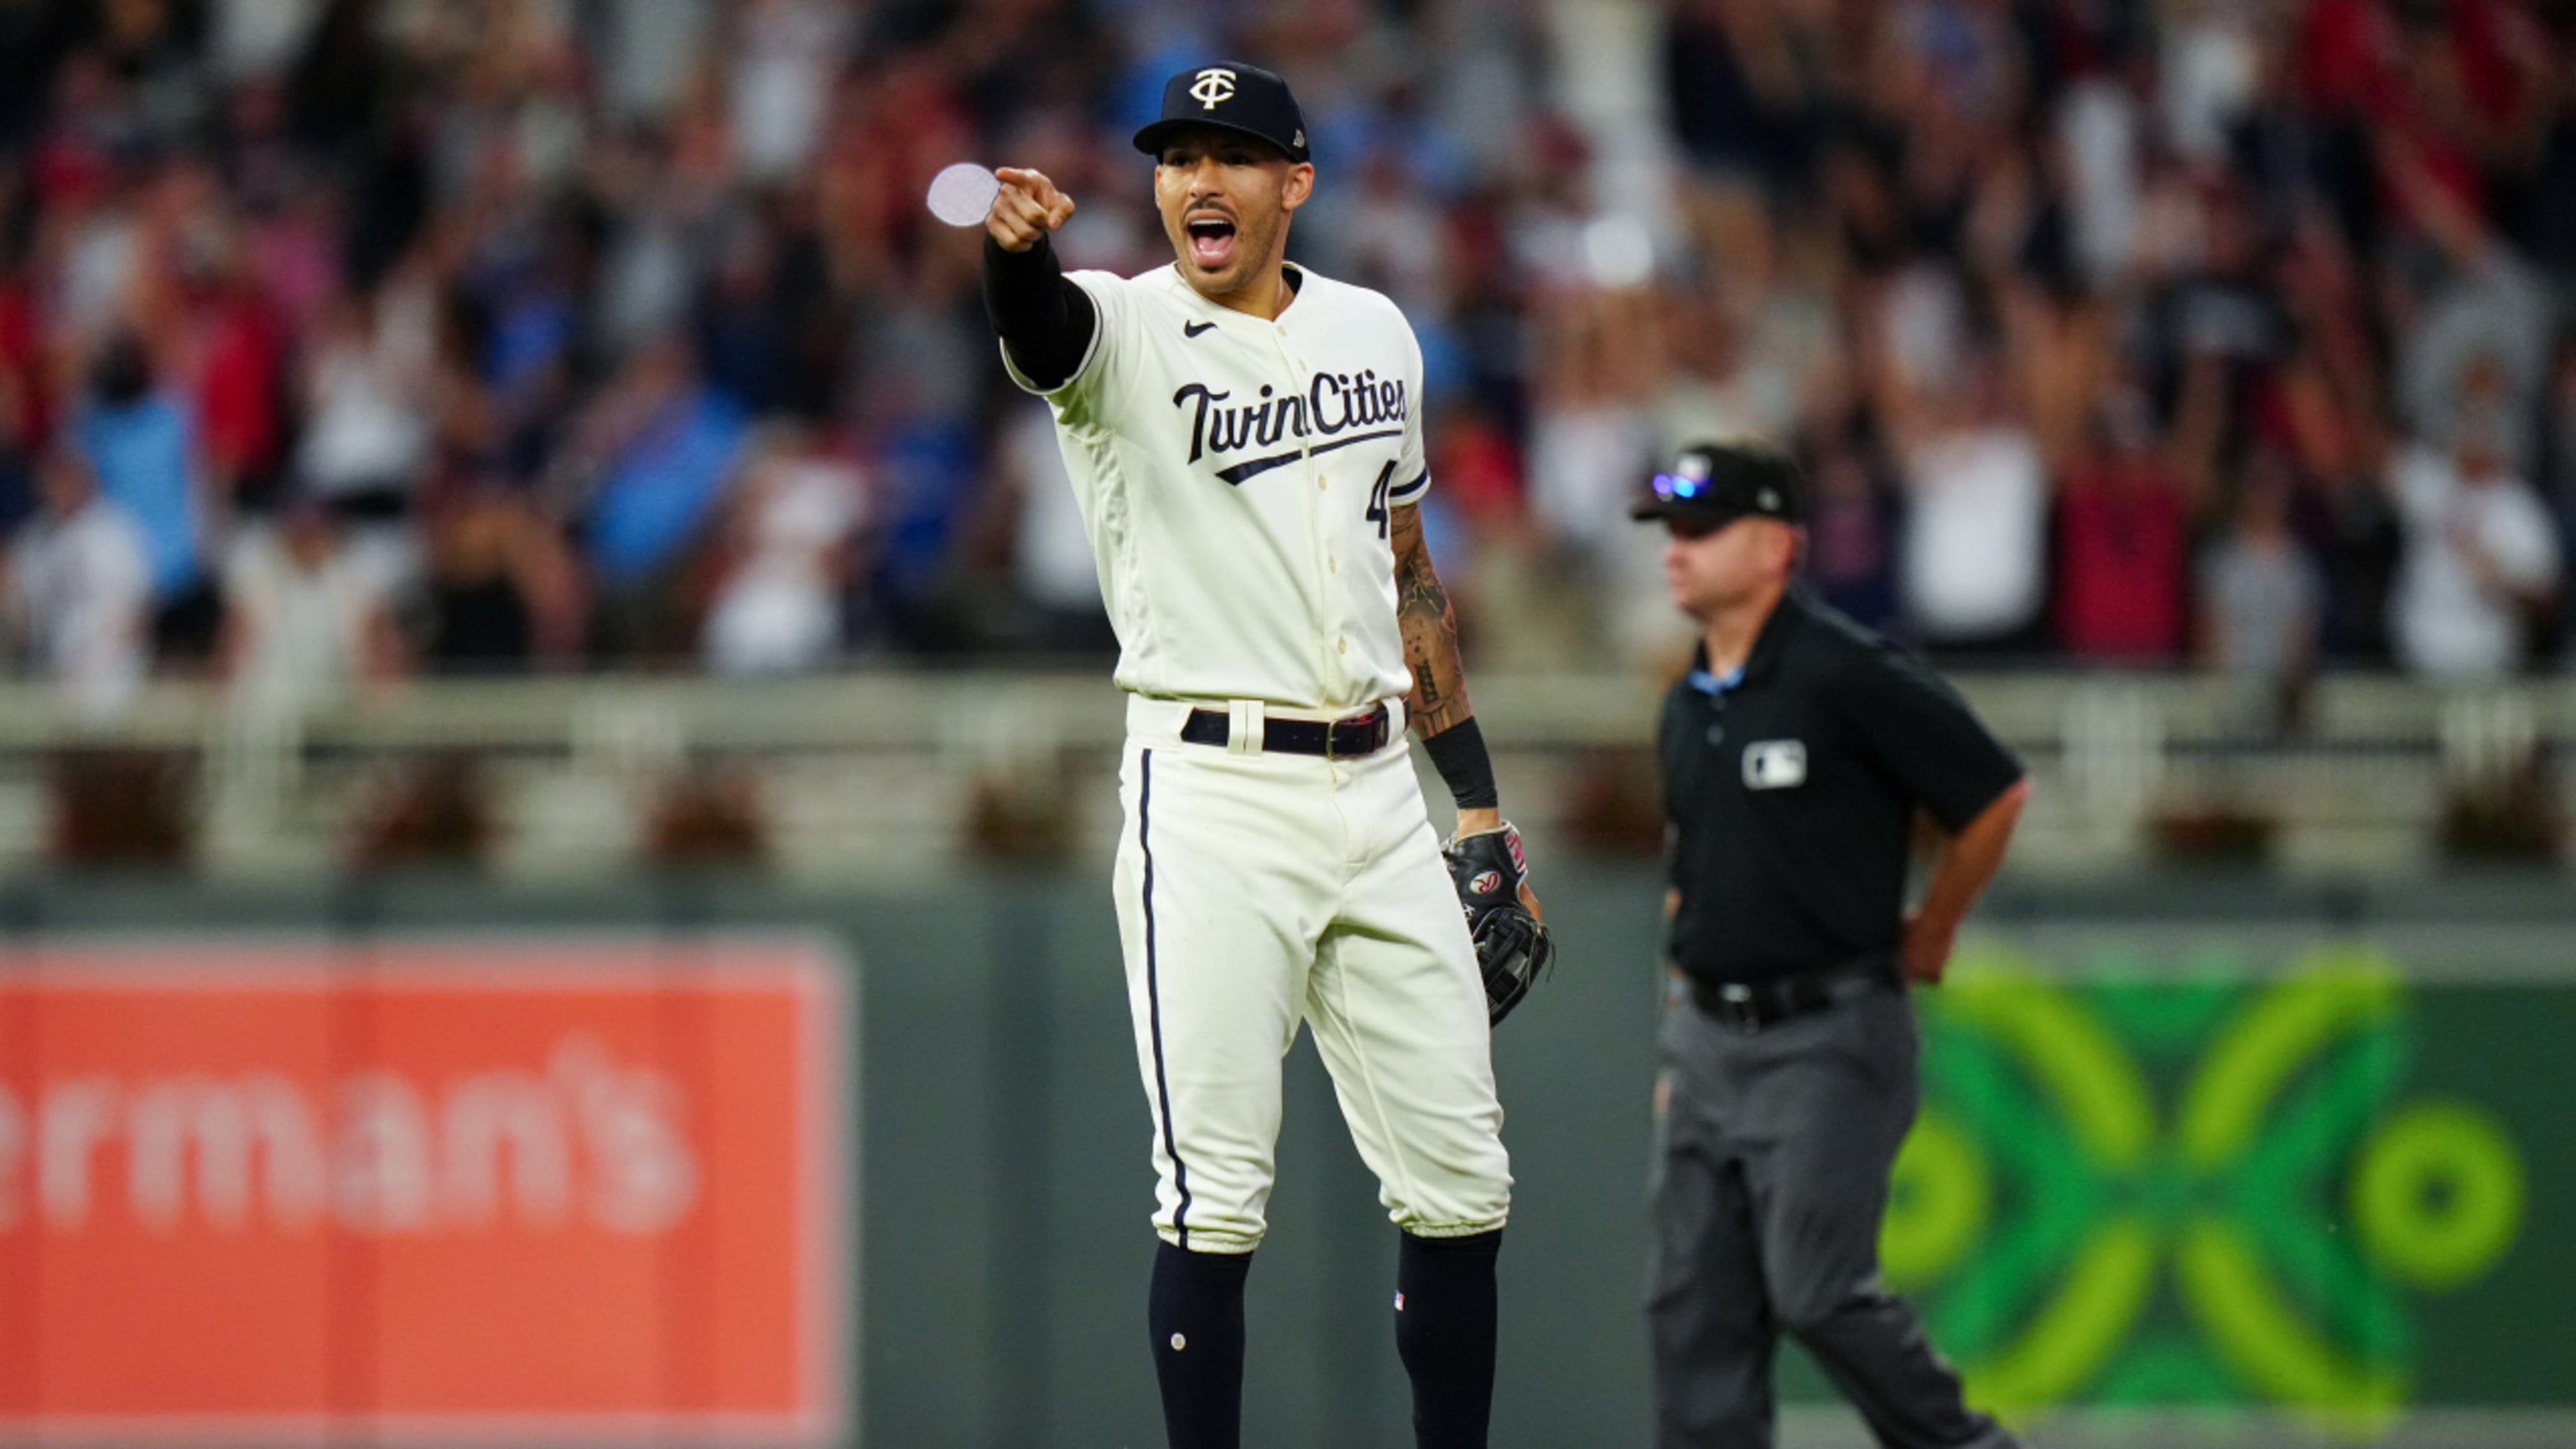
[1659,585,2023,982]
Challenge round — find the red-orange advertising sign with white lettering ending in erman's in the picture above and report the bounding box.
[0,938,848,1444]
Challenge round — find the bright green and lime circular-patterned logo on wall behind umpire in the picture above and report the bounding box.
[1881,946,2525,1431]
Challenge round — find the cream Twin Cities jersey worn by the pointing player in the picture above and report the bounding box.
[1002,266,1430,712]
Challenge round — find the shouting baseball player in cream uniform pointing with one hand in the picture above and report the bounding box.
[984,62,1545,1449]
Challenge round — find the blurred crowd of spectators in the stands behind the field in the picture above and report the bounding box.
[0,0,2576,712]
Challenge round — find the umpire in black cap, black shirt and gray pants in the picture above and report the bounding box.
[1631,444,2030,1449]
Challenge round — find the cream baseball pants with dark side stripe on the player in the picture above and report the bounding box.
[1115,696,1512,1253]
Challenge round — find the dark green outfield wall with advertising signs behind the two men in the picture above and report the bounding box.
[0,866,2576,1449]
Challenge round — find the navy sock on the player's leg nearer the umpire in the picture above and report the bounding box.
[1396,1228,1502,1449]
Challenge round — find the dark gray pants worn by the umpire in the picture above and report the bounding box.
[1646,974,2014,1449]
